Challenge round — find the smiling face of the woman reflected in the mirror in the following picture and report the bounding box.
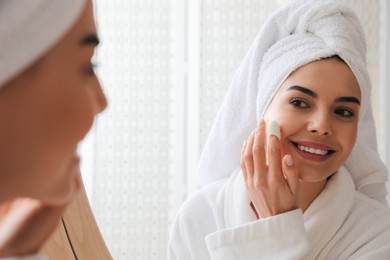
[264,58,361,182]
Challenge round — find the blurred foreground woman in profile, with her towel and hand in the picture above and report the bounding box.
[0,0,107,259]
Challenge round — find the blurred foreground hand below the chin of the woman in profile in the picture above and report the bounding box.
[0,170,81,258]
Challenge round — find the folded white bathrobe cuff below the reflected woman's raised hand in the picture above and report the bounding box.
[206,210,310,260]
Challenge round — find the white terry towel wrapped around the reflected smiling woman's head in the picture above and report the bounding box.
[198,0,387,202]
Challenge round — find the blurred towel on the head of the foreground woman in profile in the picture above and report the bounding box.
[0,0,85,87]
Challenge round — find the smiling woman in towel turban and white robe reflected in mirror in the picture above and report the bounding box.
[169,0,390,259]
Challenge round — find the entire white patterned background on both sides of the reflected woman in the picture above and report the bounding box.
[80,0,390,260]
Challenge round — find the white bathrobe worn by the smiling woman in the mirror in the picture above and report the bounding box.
[168,167,390,260]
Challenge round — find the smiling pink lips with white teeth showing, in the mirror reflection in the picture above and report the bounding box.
[291,141,335,162]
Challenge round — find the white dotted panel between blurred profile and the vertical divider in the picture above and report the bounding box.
[92,0,173,260]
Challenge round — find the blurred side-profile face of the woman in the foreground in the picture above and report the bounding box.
[0,1,106,204]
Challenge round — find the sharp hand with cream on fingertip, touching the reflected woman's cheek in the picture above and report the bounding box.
[241,120,299,218]
